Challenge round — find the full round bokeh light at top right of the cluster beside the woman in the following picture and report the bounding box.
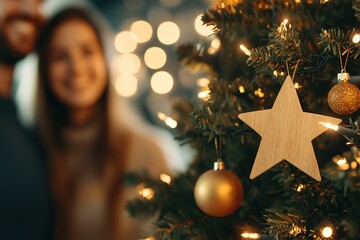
[157,21,180,45]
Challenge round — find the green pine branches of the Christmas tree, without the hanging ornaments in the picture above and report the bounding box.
[129,0,360,240]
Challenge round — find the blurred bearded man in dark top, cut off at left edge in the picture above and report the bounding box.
[0,0,52,240]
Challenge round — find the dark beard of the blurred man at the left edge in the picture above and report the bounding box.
[0,29,26,66]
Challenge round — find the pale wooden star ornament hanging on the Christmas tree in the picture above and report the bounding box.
[238,76,341,181]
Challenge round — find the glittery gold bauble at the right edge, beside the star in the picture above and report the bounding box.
[328,81,360,115]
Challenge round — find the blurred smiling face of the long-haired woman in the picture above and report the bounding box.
[49,20,107,110]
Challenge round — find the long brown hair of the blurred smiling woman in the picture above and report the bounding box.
[36,7,129,238]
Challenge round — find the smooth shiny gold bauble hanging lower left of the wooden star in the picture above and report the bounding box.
[194,169,243,217]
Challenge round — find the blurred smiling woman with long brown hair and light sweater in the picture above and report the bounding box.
[36,7,181,240]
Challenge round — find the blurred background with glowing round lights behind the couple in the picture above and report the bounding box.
[15,0,217,129]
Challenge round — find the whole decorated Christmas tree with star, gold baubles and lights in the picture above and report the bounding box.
[128,0,360,240]
